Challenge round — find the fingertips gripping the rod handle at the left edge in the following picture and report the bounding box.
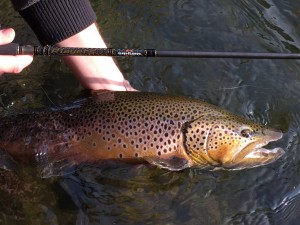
[0,28,33,75]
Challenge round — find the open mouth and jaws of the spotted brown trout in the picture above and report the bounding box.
[225,129,285,169]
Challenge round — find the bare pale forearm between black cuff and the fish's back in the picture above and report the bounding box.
[57,24,126,91]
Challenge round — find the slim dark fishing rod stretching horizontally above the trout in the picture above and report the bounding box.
[0,43,300,59]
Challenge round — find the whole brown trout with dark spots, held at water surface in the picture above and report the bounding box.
[0,91,284,176]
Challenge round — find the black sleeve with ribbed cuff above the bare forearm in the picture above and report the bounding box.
[12,0,96,45]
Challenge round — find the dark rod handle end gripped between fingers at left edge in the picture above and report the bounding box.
[0,43,34,55]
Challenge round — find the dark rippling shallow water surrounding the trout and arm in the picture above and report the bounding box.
[0,0,300,225]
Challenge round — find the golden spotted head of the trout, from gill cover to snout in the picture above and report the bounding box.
[182,115,284,170]
